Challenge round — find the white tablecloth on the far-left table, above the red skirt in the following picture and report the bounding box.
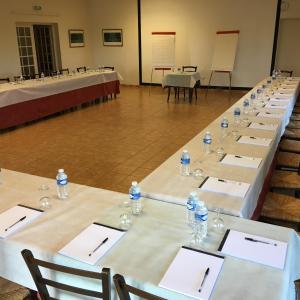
[0,71,122,108]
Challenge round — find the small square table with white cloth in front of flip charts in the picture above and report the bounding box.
[162,72,200,101]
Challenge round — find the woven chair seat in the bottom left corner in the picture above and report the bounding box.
[0,277,30,300]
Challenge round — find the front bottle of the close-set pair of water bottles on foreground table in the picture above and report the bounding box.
[194,201,208,242]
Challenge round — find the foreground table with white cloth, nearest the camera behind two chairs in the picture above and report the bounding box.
[0,170,300,300]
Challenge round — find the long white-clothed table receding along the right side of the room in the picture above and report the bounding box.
[140,80,299,218]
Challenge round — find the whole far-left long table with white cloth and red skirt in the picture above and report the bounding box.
[0,70,121,129]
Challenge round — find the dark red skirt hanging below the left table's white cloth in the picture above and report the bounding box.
[0,80,120,129]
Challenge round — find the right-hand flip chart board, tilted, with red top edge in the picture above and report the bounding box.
[211,30,239,72]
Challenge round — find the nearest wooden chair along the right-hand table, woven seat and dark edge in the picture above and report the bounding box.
[259,192,300,231]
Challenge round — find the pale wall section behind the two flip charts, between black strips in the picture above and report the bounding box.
[141,0,277,87]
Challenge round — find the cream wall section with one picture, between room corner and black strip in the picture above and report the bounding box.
[89,0,139,85]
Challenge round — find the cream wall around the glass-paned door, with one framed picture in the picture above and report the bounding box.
[0,0,92,77]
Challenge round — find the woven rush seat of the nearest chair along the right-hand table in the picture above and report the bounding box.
[261,192,300,223]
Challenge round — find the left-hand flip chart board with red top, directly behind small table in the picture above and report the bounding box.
[152,32,175,67]
